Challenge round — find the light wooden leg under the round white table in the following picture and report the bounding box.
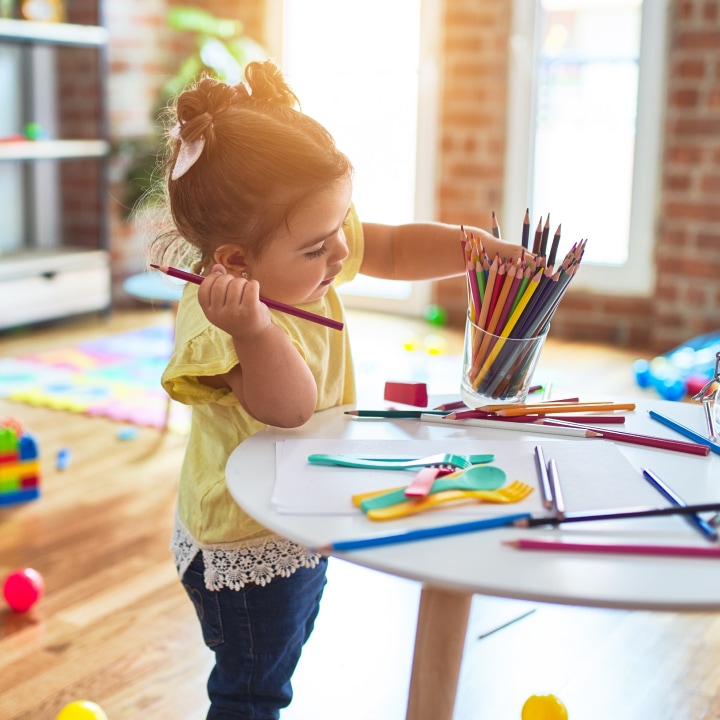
[406,586,472,720]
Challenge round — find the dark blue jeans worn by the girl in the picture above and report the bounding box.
[182,553,327,720]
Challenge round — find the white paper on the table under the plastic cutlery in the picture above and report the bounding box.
[272,439,662,517]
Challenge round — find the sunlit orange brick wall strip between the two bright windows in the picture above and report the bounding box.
[434,0,512,334]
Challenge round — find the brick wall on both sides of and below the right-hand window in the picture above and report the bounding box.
[435,0,720,352]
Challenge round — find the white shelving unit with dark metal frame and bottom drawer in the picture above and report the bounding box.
[0,13,111,330]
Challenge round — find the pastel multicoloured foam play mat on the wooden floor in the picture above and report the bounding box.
[0,324,190,433]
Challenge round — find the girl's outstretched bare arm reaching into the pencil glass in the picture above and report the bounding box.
[361,222,529,280]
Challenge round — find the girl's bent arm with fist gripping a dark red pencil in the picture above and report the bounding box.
[198,265,317,427]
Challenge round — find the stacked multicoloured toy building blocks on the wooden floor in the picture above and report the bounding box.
[0,418,40,506]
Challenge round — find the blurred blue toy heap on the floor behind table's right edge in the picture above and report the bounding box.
[633,330,720,400]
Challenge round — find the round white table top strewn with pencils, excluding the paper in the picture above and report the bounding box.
[227,398,720,611]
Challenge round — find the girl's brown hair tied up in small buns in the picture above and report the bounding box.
[149,61,352,268]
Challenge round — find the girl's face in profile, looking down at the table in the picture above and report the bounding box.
[250,178,352,305]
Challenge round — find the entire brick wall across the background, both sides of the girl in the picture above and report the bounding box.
[101,0,720,352]
